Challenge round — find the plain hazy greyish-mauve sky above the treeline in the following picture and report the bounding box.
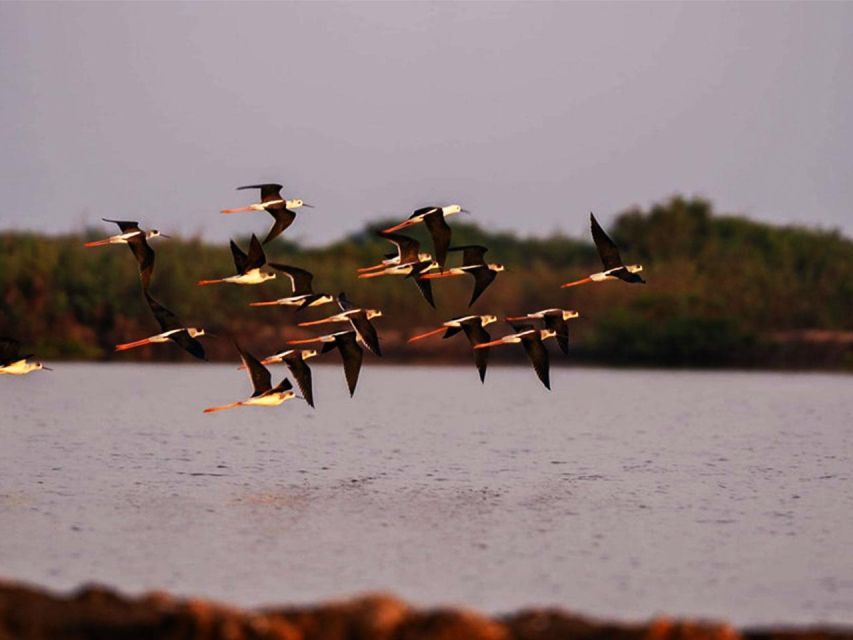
[0,2,853,242]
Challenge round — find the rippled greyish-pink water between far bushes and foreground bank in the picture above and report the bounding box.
[0,364,853,625]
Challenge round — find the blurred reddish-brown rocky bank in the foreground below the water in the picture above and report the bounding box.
[0,582,853,640]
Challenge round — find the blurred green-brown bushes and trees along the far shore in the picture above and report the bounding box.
[0,196,853,371]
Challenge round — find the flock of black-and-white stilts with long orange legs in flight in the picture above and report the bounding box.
[0,184,645,413]
